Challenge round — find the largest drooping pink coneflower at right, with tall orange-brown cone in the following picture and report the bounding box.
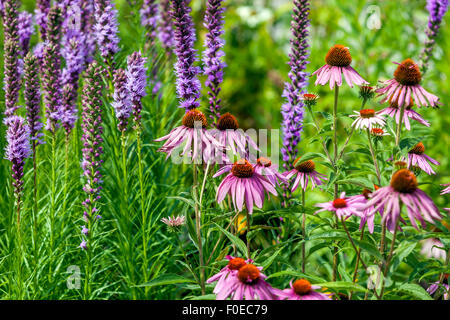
[366,169,442,230]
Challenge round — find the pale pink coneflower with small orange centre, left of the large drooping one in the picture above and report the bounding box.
[314,192,366,219]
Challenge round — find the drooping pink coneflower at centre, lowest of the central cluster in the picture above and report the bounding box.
[214,159,277,214]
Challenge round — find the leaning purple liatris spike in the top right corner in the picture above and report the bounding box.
[420,0,448,74]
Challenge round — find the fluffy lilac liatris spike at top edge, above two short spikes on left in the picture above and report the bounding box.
[94,0,119,60]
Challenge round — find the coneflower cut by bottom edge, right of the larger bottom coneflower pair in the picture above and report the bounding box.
[277,279,331,300]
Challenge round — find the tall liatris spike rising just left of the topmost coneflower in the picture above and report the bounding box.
[281,0,310,169]
